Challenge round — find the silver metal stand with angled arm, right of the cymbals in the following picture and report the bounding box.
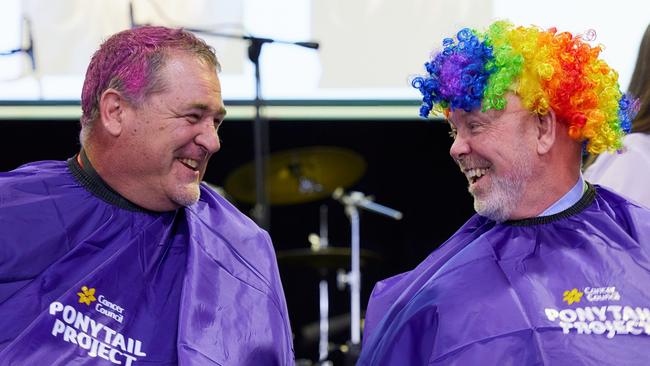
[332,188,403,348]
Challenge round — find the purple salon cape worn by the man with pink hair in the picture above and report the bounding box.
[0,159,294,365]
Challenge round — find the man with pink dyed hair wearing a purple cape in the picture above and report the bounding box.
[0,27,294,365]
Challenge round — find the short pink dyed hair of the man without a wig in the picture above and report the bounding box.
[81,26,219,127]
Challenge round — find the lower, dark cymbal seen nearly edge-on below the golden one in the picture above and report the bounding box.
[277,247,381,269]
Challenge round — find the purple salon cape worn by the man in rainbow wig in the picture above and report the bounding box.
[358,186,650,366]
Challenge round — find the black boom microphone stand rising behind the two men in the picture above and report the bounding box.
[185,28,319,231]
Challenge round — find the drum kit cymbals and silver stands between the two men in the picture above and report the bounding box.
[224,146,402,365]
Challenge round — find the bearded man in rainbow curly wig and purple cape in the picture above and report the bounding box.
[359,22,650,365]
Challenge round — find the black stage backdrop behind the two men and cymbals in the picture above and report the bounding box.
[0,116,473,359]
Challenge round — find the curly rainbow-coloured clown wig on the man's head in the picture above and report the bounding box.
[412,21,638,154]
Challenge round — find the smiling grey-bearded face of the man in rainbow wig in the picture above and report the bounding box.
[449,94,537,222]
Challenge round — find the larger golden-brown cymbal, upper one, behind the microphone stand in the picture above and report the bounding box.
[225,146,366,205]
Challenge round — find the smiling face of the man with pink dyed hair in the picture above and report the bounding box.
[116,52,225,211]
